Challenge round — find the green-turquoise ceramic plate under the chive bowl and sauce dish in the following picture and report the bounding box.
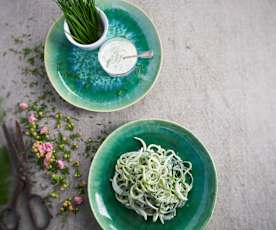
[45,0,162,112]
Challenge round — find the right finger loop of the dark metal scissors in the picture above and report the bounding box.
[27,194,52,230]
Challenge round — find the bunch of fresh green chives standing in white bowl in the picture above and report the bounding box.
[57,0,104,44]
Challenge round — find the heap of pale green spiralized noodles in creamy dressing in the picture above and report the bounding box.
[111,137,193,223]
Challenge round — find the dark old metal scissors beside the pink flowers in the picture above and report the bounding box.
[0,121,52,230]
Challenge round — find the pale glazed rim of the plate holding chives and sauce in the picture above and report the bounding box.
[44,0,163,113]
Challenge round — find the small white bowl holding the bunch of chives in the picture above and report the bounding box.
[64,7,109,50]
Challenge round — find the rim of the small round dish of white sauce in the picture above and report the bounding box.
[98,37,138,77]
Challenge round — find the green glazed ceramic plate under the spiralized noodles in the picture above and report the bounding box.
[88,120,217,230]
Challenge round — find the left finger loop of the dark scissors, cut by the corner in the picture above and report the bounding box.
[0,208,20,230]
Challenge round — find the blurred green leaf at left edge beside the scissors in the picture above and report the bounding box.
[0,147,14,210]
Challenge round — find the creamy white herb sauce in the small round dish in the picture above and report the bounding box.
[98,37,138,76]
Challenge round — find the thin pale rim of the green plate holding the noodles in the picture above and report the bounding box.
[87,118,218,229]
